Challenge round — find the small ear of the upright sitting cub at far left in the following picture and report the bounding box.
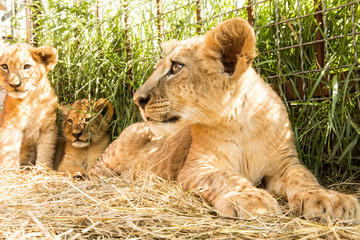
[33,46,58,71]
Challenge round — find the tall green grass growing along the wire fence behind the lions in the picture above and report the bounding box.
[0,0,360,183]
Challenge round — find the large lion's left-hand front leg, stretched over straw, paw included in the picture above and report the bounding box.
[177,157,279,219]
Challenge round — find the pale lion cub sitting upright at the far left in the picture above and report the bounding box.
[0,43,58,169]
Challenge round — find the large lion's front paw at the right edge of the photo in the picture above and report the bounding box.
[289,189,360,222]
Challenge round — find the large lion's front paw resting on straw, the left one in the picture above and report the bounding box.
[214,188,279,219]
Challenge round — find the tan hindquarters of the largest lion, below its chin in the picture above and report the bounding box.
[89,123,191,179]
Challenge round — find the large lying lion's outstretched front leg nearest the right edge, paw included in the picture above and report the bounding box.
[267,163,360,221]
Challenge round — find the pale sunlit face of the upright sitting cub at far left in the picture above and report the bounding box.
[0,43,58,98]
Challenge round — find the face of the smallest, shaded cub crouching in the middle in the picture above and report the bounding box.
[60,98,114,148]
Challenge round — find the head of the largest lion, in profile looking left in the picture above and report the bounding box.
[134,20,256,134]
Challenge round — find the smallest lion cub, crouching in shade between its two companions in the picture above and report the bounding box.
[58,98,114,176]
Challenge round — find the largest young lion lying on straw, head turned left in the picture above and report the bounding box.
[91,19,359,220]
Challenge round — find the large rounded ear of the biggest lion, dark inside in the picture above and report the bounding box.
[204,18,256,78]
